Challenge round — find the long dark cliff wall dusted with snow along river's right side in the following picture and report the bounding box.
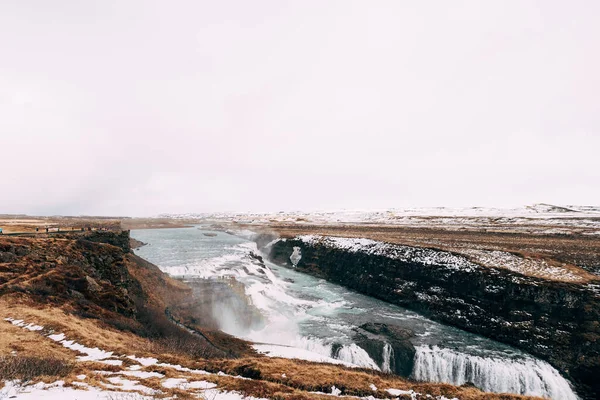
[259,239,600,398]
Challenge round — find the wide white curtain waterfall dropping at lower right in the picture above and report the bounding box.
[412,346,578,400]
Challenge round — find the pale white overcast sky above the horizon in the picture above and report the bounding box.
[0,0,600,216]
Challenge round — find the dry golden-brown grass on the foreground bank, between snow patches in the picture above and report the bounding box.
[0,300,544,400]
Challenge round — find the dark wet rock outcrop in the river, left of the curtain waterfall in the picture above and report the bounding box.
[353,322,416,377]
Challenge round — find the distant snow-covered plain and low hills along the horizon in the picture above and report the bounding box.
[160,204,600,235]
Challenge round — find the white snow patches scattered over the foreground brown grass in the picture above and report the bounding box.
[0,318,458,400]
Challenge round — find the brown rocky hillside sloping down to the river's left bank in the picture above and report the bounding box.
[0,231,250,357]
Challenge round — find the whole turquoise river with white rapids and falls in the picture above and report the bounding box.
[132,228,577,400]
